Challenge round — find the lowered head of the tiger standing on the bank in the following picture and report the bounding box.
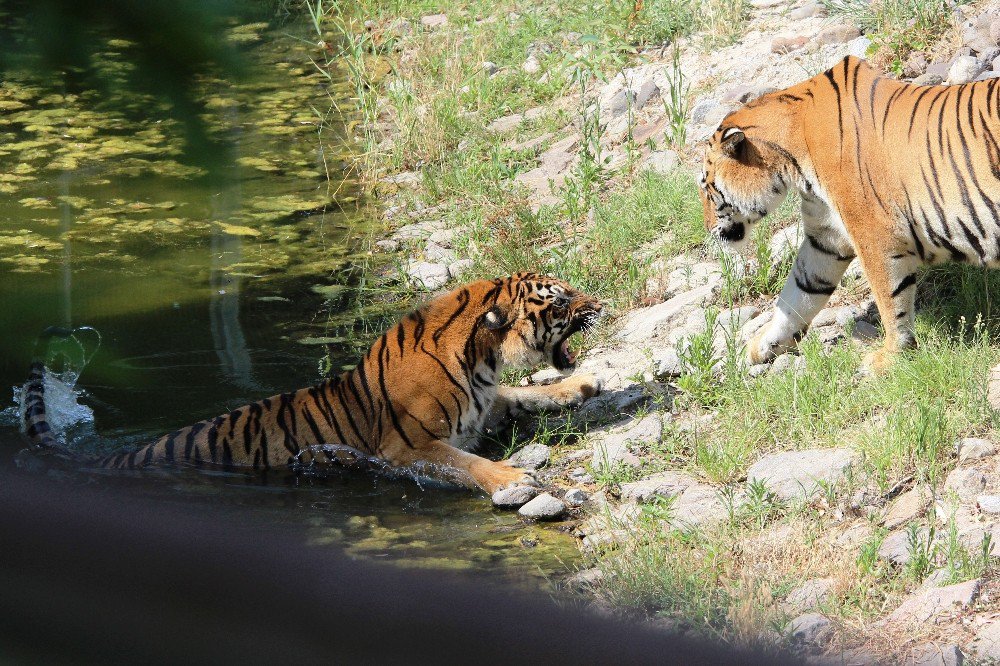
[700,122,788,252]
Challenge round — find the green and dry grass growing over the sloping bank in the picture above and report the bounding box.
[319,0,1000,652]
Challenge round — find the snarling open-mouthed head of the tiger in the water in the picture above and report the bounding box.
[482,273,603,372]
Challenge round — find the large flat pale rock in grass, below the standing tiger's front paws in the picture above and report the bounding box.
[747,449,858,501]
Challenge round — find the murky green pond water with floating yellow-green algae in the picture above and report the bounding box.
[0,15,578,586]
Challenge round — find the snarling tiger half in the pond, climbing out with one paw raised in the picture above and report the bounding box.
[24,273,602,494]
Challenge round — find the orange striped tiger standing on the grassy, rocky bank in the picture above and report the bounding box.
[701,56,1000,372]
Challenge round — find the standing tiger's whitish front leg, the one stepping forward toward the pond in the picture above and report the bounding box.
[747,226,854,364]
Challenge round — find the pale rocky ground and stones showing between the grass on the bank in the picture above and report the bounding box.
[360,0,1000,664]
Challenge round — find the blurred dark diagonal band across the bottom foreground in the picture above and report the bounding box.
[0,464,793,665]
